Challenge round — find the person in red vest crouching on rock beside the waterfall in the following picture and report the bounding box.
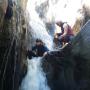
[56,21,74,46]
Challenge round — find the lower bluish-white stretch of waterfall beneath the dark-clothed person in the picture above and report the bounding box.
[20,58,50,90]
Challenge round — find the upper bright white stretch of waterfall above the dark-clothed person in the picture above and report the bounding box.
[26,0,53,50]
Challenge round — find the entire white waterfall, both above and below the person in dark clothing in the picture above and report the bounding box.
[20,0,53,90]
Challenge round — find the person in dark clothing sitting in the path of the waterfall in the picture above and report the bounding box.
[27,39,49,59]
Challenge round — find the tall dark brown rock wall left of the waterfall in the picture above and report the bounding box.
[0,0,27,90]
